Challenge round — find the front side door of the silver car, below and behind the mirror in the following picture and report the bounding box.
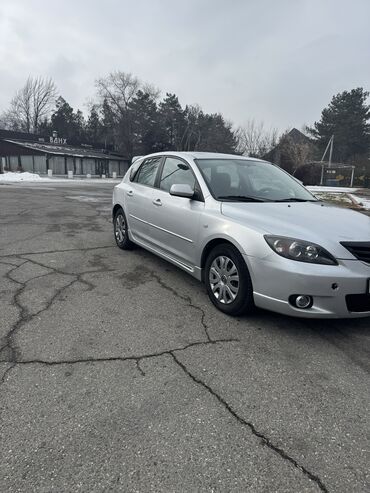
[151,157,204,267]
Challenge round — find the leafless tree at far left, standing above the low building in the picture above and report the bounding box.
[2,77,57,133]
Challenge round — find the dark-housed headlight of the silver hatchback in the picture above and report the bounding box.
[265,235,338,265]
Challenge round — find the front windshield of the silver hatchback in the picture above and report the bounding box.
[195,158,316,202]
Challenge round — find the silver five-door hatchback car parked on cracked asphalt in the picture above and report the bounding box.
[113,152,370,318]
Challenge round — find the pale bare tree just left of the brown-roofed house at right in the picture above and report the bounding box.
[235,119,278,157]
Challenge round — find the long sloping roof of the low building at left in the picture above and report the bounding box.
[2,138,125,161]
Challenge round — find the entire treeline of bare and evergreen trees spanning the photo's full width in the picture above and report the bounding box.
[0,71,370,172]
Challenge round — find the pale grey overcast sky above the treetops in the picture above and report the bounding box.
[0,0,370,130]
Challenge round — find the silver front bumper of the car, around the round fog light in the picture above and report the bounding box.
[244,254,370,318]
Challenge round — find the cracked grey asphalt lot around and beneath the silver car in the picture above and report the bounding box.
[0,183,370,493]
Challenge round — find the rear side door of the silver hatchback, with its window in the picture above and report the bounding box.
[124,156,162,243]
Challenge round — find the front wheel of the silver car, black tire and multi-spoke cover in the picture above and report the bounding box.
[204,243,254,316]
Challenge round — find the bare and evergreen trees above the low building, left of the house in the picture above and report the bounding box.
[0,72,237,157]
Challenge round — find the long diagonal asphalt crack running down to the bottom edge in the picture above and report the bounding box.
[170,351,328,493]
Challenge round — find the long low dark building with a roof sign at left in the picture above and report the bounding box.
[0,130,129,176]
